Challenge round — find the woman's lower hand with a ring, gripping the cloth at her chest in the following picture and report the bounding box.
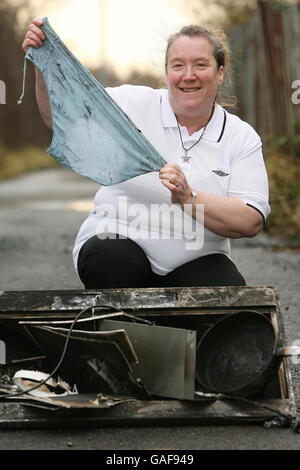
[159,163,191,206]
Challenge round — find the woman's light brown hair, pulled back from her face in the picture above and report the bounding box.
[165,24,237,107]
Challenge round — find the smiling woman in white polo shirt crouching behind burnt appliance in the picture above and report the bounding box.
[23,20,270,288]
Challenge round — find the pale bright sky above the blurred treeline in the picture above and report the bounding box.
[25,0,218,77]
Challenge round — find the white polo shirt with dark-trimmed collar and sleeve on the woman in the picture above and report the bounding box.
[73,85,270,275]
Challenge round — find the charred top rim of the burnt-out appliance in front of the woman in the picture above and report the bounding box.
[0,286,276,320]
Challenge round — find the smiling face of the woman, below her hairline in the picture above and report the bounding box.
[166,36,224,117]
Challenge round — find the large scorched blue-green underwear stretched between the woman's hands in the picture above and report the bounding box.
[19,18,166,186]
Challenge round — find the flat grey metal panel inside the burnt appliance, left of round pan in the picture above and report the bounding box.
[100,320,196,400]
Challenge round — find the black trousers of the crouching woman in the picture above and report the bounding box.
[78,235,246,289]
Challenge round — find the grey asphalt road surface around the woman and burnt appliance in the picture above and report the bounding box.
[0,168,300,450]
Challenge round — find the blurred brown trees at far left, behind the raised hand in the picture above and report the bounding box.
[0,0,49,147]
